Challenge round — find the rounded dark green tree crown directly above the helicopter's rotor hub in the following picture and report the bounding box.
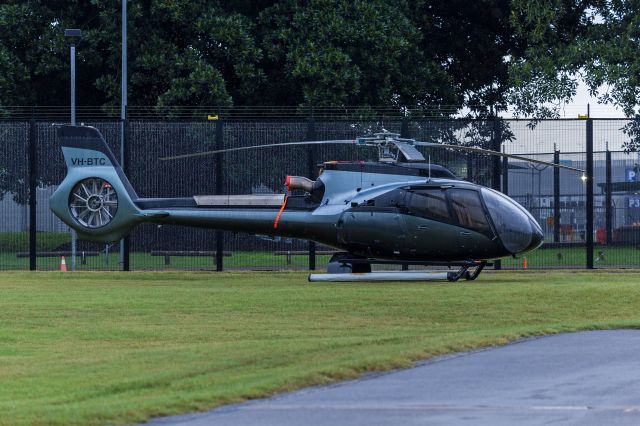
[255,0,455,106]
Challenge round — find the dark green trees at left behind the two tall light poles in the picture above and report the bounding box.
[0,0,263,110]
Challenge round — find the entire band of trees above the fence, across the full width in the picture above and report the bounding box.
[0,0,640,116]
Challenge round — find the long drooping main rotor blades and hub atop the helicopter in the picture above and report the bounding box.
[160,132,585,173]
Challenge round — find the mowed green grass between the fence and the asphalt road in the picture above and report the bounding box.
[0,271,640,425]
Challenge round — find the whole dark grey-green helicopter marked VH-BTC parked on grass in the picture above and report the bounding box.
[49,125,584,281]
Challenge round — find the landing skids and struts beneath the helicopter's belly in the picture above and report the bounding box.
[309,253,487,282]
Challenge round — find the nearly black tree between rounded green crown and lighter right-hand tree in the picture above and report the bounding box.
[410,0,524,113]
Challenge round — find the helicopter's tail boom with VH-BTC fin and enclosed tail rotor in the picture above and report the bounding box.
[49,126,330,243]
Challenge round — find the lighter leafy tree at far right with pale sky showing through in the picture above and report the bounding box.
[508,0,640,116]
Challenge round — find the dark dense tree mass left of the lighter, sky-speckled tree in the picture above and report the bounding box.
[0,0,519,110]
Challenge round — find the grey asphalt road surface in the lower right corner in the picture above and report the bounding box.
[151,330,640,426]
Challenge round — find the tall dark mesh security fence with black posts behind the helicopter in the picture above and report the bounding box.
[0,115,640,270]
